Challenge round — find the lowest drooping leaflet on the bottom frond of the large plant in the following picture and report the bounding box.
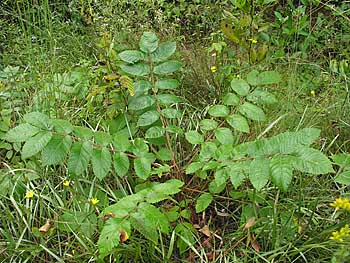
[97,218,131,260]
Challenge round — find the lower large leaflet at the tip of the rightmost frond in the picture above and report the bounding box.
[293,147,334,174]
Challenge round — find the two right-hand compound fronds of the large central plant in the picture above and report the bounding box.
[185,70,334,212]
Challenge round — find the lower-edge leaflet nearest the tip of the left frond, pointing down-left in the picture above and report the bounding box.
[22,131,52,159]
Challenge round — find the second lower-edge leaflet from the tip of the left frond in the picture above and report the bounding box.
[41,134,72,165]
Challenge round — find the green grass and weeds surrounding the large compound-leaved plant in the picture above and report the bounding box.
[0,1,350,262]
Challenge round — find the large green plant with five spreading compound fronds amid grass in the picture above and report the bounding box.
[5,32,333,258]
